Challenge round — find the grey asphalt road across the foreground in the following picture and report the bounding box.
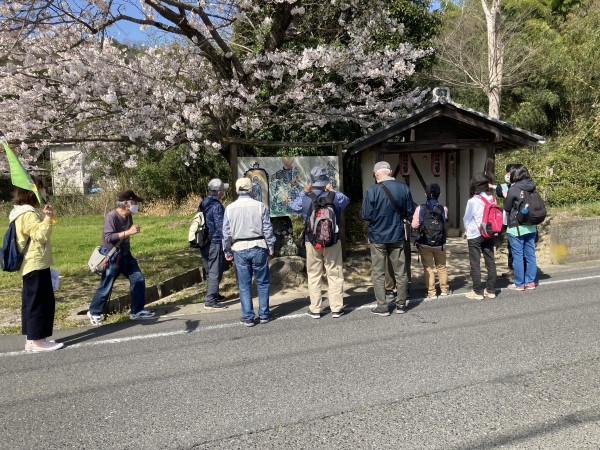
[0,268,600,450]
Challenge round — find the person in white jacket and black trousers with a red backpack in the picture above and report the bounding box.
[463,172,496,300]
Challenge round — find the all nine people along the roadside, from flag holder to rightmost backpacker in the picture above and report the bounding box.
[10,161,537,352]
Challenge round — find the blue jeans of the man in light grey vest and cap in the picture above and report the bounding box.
[233,247,271,320]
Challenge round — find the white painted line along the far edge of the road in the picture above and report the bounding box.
[0,275,600,358]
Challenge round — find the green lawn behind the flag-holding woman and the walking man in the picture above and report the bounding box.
[0,215,201,333]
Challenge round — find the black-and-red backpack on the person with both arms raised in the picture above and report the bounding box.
[305,192,338,248]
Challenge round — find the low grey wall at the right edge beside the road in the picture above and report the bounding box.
[550,217,600,264]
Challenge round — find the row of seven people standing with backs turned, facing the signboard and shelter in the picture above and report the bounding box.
[199,161,537,326]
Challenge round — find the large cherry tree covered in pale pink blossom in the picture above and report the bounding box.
[0,0,428,167]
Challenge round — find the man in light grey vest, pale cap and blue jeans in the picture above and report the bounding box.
[223,178,275,327]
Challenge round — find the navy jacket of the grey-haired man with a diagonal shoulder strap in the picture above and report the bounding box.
[361,179,415,244]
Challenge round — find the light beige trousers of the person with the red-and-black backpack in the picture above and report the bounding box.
[306,241,344,314]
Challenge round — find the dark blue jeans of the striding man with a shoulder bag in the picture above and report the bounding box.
[90,249,146,315]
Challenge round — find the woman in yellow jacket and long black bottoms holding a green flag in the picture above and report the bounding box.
[9,180,64,353]
